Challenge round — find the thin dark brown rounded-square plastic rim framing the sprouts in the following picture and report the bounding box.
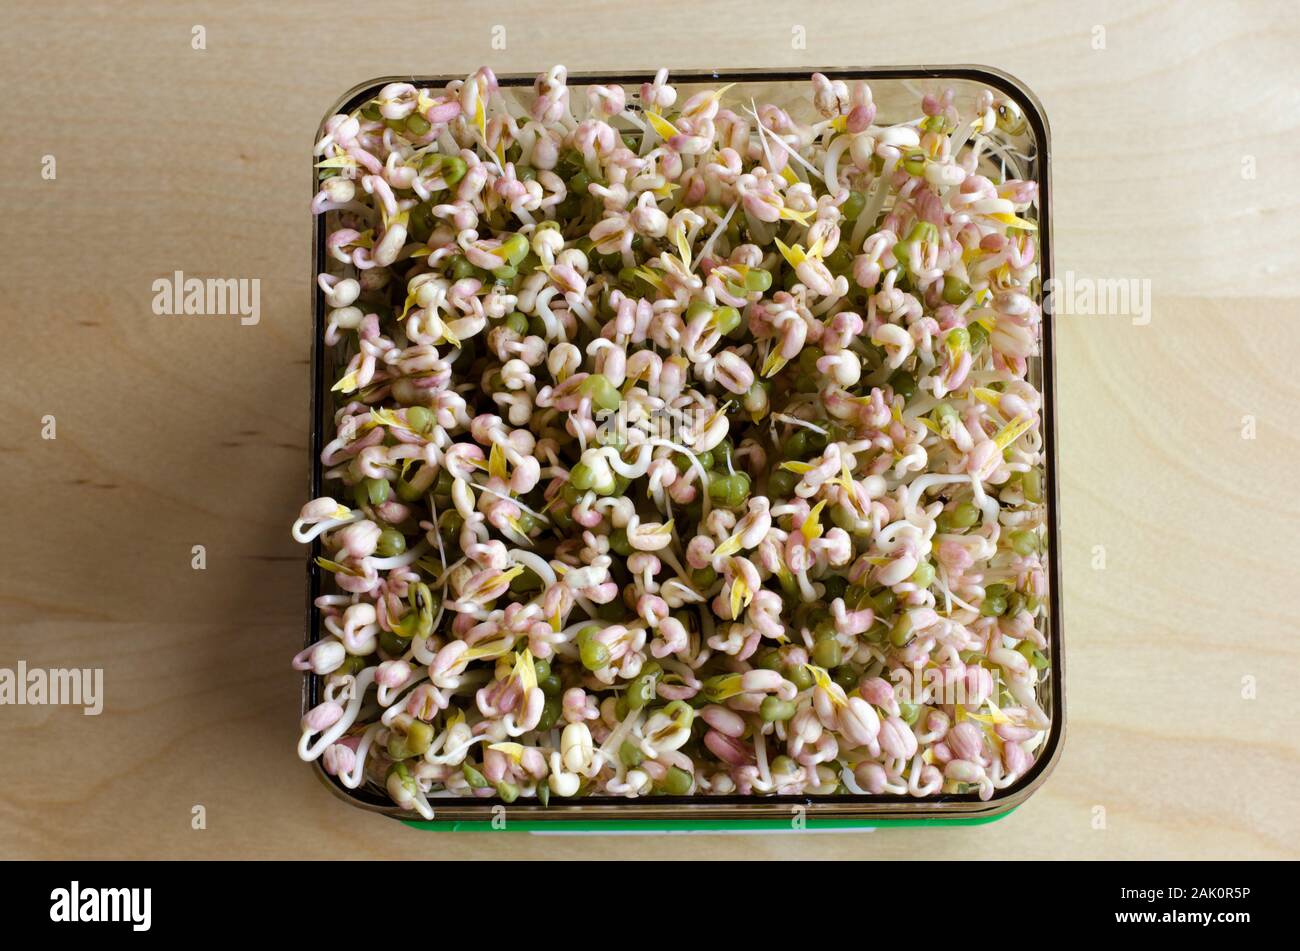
[302,64,1065,831]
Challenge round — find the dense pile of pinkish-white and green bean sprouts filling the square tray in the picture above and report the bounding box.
[294,66,1049,817]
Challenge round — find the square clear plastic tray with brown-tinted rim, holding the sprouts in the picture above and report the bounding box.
[303,65,1065,831]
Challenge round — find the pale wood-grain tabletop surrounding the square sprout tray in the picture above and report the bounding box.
[0,0,1300,859]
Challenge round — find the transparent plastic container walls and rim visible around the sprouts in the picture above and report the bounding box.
[303,66,1065,828]
